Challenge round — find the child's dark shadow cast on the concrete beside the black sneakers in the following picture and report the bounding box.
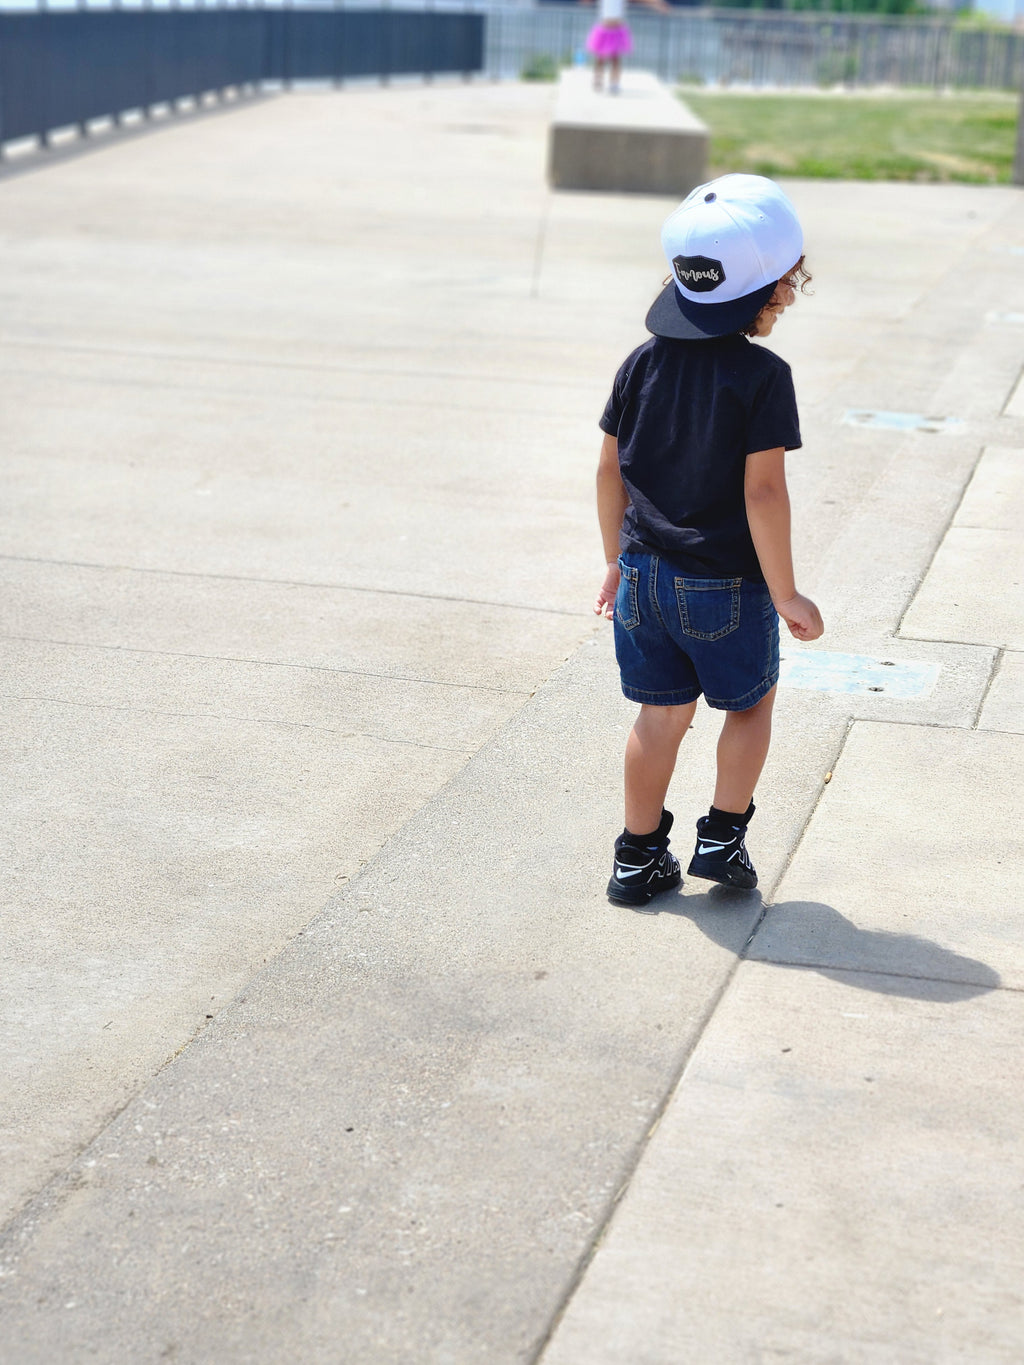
[644,886,1001,1003]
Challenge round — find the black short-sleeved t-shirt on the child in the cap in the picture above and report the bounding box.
[601,336,800,583]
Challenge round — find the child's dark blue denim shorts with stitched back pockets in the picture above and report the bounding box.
[614,551,778,711]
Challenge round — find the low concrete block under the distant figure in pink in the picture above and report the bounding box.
[547,68,710,199]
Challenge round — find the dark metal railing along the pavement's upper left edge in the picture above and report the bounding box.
[0,7,483,145]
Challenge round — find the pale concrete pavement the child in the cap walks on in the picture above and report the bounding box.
[0,86,1024,1365]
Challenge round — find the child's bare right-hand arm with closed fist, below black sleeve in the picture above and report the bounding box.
[743,446,825,640]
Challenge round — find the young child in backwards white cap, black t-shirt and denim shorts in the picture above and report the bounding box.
[594,175,823,905]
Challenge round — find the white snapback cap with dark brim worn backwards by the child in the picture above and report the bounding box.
[647,175,804,341]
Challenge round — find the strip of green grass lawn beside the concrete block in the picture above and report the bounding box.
[681,89,1019,184]
